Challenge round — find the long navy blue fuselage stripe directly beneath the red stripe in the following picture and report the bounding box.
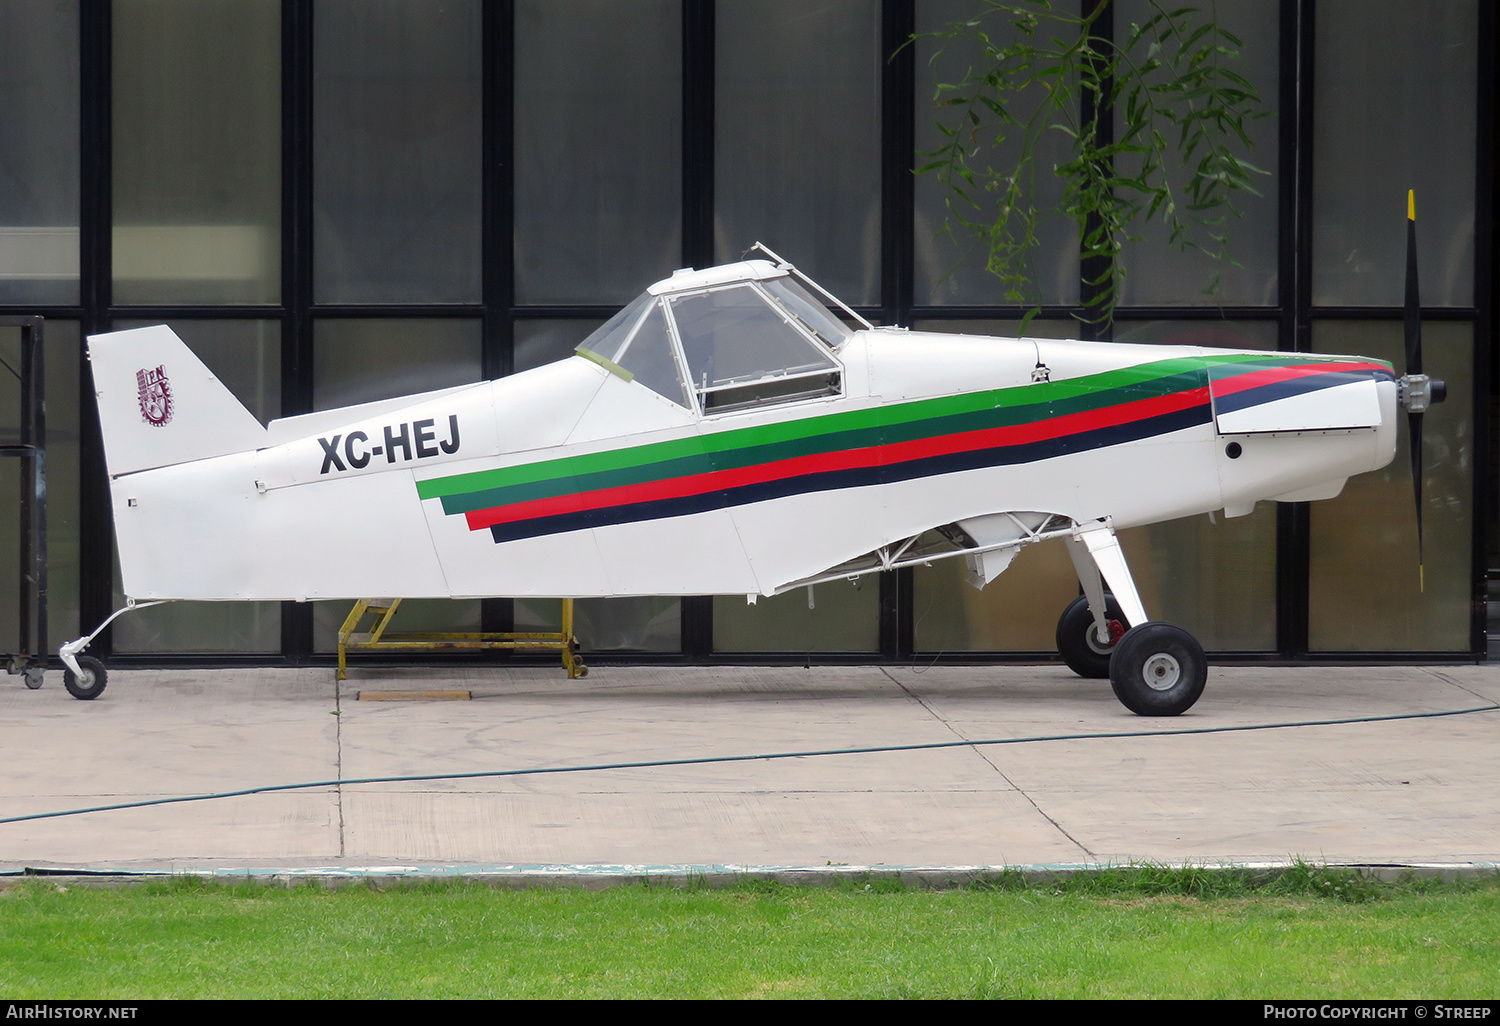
[489,404,1212,542]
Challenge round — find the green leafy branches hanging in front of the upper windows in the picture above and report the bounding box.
[918,0,1266,326]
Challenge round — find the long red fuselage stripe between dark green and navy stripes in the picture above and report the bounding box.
[464,389,1209,531]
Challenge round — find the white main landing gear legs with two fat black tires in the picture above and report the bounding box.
[1058,521,1208,716]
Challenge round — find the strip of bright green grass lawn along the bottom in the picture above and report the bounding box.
[0,867,1500,999]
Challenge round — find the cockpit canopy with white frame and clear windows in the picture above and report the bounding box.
[578,260,851,414]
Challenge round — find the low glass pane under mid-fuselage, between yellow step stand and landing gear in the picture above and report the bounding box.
[714,573,881,653]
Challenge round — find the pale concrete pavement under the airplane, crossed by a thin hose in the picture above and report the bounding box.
[0,666,1500,878]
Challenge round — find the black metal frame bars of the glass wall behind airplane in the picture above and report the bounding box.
[0,0,1500,665]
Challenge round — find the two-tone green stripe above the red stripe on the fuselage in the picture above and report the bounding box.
[417,353,1316,513]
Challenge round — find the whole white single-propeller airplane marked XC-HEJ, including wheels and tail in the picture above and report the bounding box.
[60,225,1440,716]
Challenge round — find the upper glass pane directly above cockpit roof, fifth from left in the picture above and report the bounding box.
[714,0,882,303]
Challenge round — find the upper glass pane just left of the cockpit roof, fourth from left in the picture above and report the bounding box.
[515,0,683,303]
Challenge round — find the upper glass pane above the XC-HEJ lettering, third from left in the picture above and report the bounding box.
[312,0,483,303]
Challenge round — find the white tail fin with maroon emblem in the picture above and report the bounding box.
[89,324,266,477]
